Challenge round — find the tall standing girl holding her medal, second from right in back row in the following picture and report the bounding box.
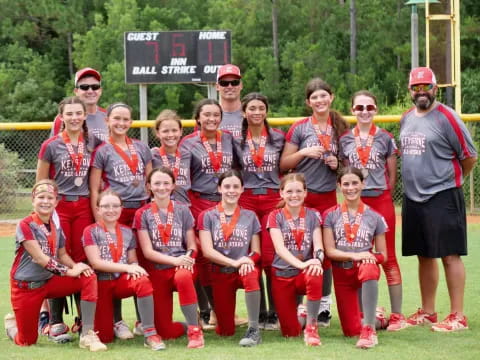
[280,78,348,326]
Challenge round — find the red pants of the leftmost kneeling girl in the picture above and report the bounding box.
[10,275,97,346]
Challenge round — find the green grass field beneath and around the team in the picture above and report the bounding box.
[0,224,480,360]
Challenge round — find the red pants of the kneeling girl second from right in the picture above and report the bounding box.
[272,268,323,336]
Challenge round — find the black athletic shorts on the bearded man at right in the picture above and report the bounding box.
[402,188,467,258]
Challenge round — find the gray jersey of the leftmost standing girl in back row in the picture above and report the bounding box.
[38,135,92,196]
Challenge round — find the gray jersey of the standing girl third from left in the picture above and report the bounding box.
[151,147,190,205]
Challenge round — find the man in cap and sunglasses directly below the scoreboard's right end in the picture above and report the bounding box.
[216,64,243,139]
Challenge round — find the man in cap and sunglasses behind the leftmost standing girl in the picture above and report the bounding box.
[50,67,108,142]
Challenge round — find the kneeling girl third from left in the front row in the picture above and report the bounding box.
[134,167,204,348]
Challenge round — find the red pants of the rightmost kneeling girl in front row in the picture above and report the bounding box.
[333,264,380,336]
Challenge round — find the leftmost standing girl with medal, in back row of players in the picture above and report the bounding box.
[36,96,98,342]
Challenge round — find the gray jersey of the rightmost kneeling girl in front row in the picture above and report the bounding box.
[323,205,388,252]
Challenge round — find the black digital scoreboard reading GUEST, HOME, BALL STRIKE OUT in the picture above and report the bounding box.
[124,30,231,84]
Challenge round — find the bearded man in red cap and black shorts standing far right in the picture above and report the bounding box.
[400,67,477,332]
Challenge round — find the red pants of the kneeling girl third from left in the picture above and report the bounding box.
[150,268,197,339]
